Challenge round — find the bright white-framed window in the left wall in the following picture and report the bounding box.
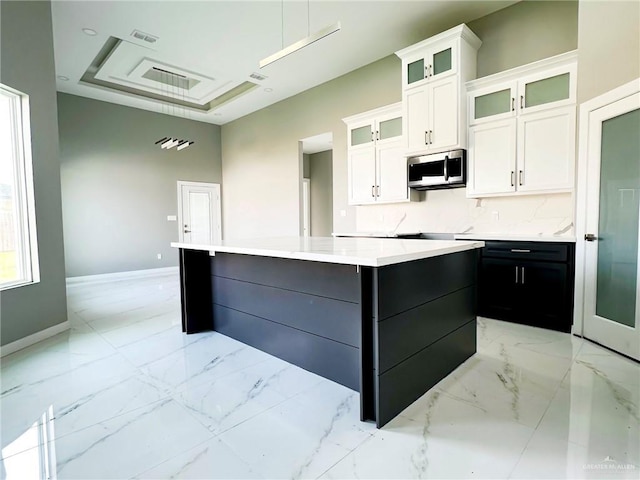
[0,84,40,290]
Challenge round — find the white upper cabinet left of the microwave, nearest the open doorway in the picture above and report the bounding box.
[343,103,415,205]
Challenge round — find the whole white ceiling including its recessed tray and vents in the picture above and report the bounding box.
[52,0,515,124]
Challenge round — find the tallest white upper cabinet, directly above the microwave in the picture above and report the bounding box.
[396,25,481,156]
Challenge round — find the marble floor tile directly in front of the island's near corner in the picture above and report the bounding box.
[322,391,534,479]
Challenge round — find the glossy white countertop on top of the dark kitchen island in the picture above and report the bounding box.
[171,237,484,267]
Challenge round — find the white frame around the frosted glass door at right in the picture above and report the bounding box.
[571,78,640,336]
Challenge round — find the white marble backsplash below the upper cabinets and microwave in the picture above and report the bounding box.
[356,188,575,237]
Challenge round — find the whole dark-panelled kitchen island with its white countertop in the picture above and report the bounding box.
[172,237,484,427]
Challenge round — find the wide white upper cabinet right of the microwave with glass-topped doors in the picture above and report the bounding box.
[467,52,577,197]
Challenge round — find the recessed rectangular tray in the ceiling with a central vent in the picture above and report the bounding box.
[81,37,258,112]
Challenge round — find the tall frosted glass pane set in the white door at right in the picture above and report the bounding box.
[596,110,640,327]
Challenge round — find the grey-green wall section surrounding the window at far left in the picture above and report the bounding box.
[0,1,67,345]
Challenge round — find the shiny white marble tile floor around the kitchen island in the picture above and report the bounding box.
[0,275,640,480]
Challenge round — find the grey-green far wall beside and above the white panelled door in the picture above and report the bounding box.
[58,93,222,277]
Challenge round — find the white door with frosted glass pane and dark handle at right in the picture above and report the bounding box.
[583,93,640,360]
